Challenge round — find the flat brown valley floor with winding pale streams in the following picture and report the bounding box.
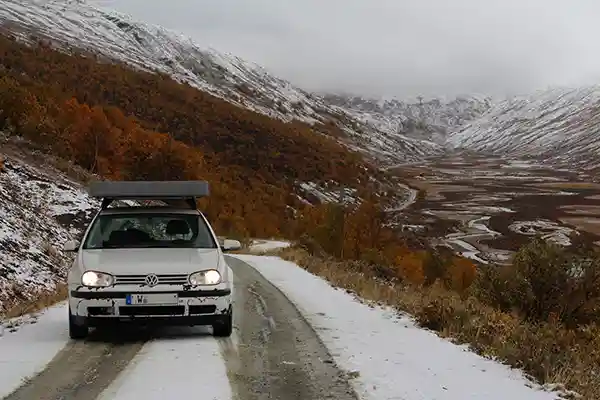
[395,154,600,263]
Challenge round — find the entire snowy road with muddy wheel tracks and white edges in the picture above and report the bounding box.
[0,241,556,400]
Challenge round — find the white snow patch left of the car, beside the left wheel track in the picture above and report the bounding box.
[0,303,69,398]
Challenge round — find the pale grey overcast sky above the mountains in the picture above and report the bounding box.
[88,0,600,98]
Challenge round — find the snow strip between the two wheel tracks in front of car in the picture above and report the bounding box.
[98,327,232,400]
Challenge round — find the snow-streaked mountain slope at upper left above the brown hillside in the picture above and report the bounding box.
[0,0,462,165]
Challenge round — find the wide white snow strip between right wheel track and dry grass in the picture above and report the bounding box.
[235,255,558,400]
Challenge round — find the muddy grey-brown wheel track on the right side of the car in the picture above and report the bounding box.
[219,257,357,400]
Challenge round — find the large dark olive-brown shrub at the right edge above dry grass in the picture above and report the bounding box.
[474,239,600,327]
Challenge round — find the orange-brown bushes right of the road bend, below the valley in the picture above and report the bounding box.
[296,199,476,292]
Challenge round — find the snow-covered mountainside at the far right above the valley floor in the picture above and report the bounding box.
[448,85,600,169]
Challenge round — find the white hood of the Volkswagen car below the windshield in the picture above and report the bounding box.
[80,248,221,275]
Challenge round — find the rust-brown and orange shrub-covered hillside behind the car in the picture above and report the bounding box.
[0,32,380,237]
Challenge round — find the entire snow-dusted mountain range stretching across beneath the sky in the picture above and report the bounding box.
[0,0,600,168]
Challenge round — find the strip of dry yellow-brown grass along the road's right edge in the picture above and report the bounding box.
[271,248,600,399]
